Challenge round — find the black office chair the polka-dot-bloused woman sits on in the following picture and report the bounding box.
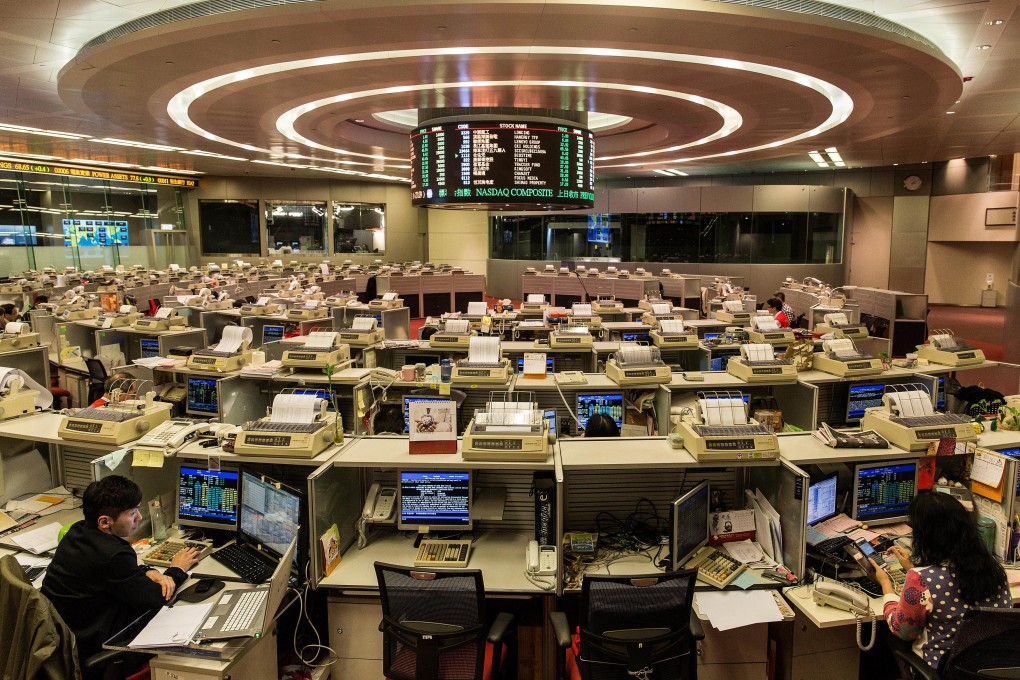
[893,607,1020,680]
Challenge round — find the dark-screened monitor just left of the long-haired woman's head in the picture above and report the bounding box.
[853,460,917,524]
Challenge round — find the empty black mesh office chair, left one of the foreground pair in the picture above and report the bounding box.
[375,562,513,680]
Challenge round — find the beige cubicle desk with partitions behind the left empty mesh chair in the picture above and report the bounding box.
[308,436,556,678]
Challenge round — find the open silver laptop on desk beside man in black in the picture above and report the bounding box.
[195,538,298,641]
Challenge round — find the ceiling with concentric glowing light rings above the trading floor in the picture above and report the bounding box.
[0,0,1020,181]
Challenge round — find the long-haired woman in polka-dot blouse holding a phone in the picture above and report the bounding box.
[875,491,1013,669]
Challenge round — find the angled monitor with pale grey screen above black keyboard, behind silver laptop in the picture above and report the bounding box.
[238,471,301,562]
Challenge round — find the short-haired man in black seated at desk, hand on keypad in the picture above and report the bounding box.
[43,475,198,680]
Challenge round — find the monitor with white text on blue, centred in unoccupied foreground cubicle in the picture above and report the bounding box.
[397,470,472,533]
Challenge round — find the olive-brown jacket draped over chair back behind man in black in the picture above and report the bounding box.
[0,555,80,678]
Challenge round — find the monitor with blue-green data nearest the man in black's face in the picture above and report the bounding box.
[177,465,238,531]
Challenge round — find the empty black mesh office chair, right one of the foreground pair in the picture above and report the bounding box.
[549,570,705,680]
